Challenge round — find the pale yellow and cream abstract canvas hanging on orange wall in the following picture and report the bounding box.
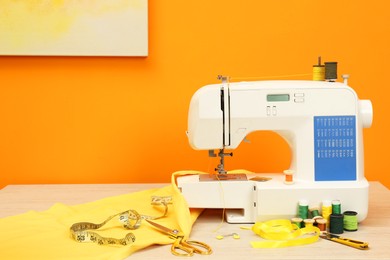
[0,0,148,56]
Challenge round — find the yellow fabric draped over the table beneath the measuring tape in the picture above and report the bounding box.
[0,171,201,260]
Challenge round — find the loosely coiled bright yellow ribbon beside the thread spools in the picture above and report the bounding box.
[251,219,320,248]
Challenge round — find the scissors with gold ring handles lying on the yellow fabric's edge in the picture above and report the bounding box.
[146,220,213,256]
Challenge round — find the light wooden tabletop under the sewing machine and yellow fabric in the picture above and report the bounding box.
[0,182,390,260]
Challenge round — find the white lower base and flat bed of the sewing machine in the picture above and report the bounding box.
[177,174,369,223]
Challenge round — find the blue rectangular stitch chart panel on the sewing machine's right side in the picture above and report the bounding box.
[314,116,357,181]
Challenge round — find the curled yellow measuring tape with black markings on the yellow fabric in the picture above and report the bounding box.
[70,196,172,246]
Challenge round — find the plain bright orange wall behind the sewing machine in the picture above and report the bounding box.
[0,0,390,187]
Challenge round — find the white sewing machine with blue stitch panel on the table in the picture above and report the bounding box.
[177,77,373,223]
